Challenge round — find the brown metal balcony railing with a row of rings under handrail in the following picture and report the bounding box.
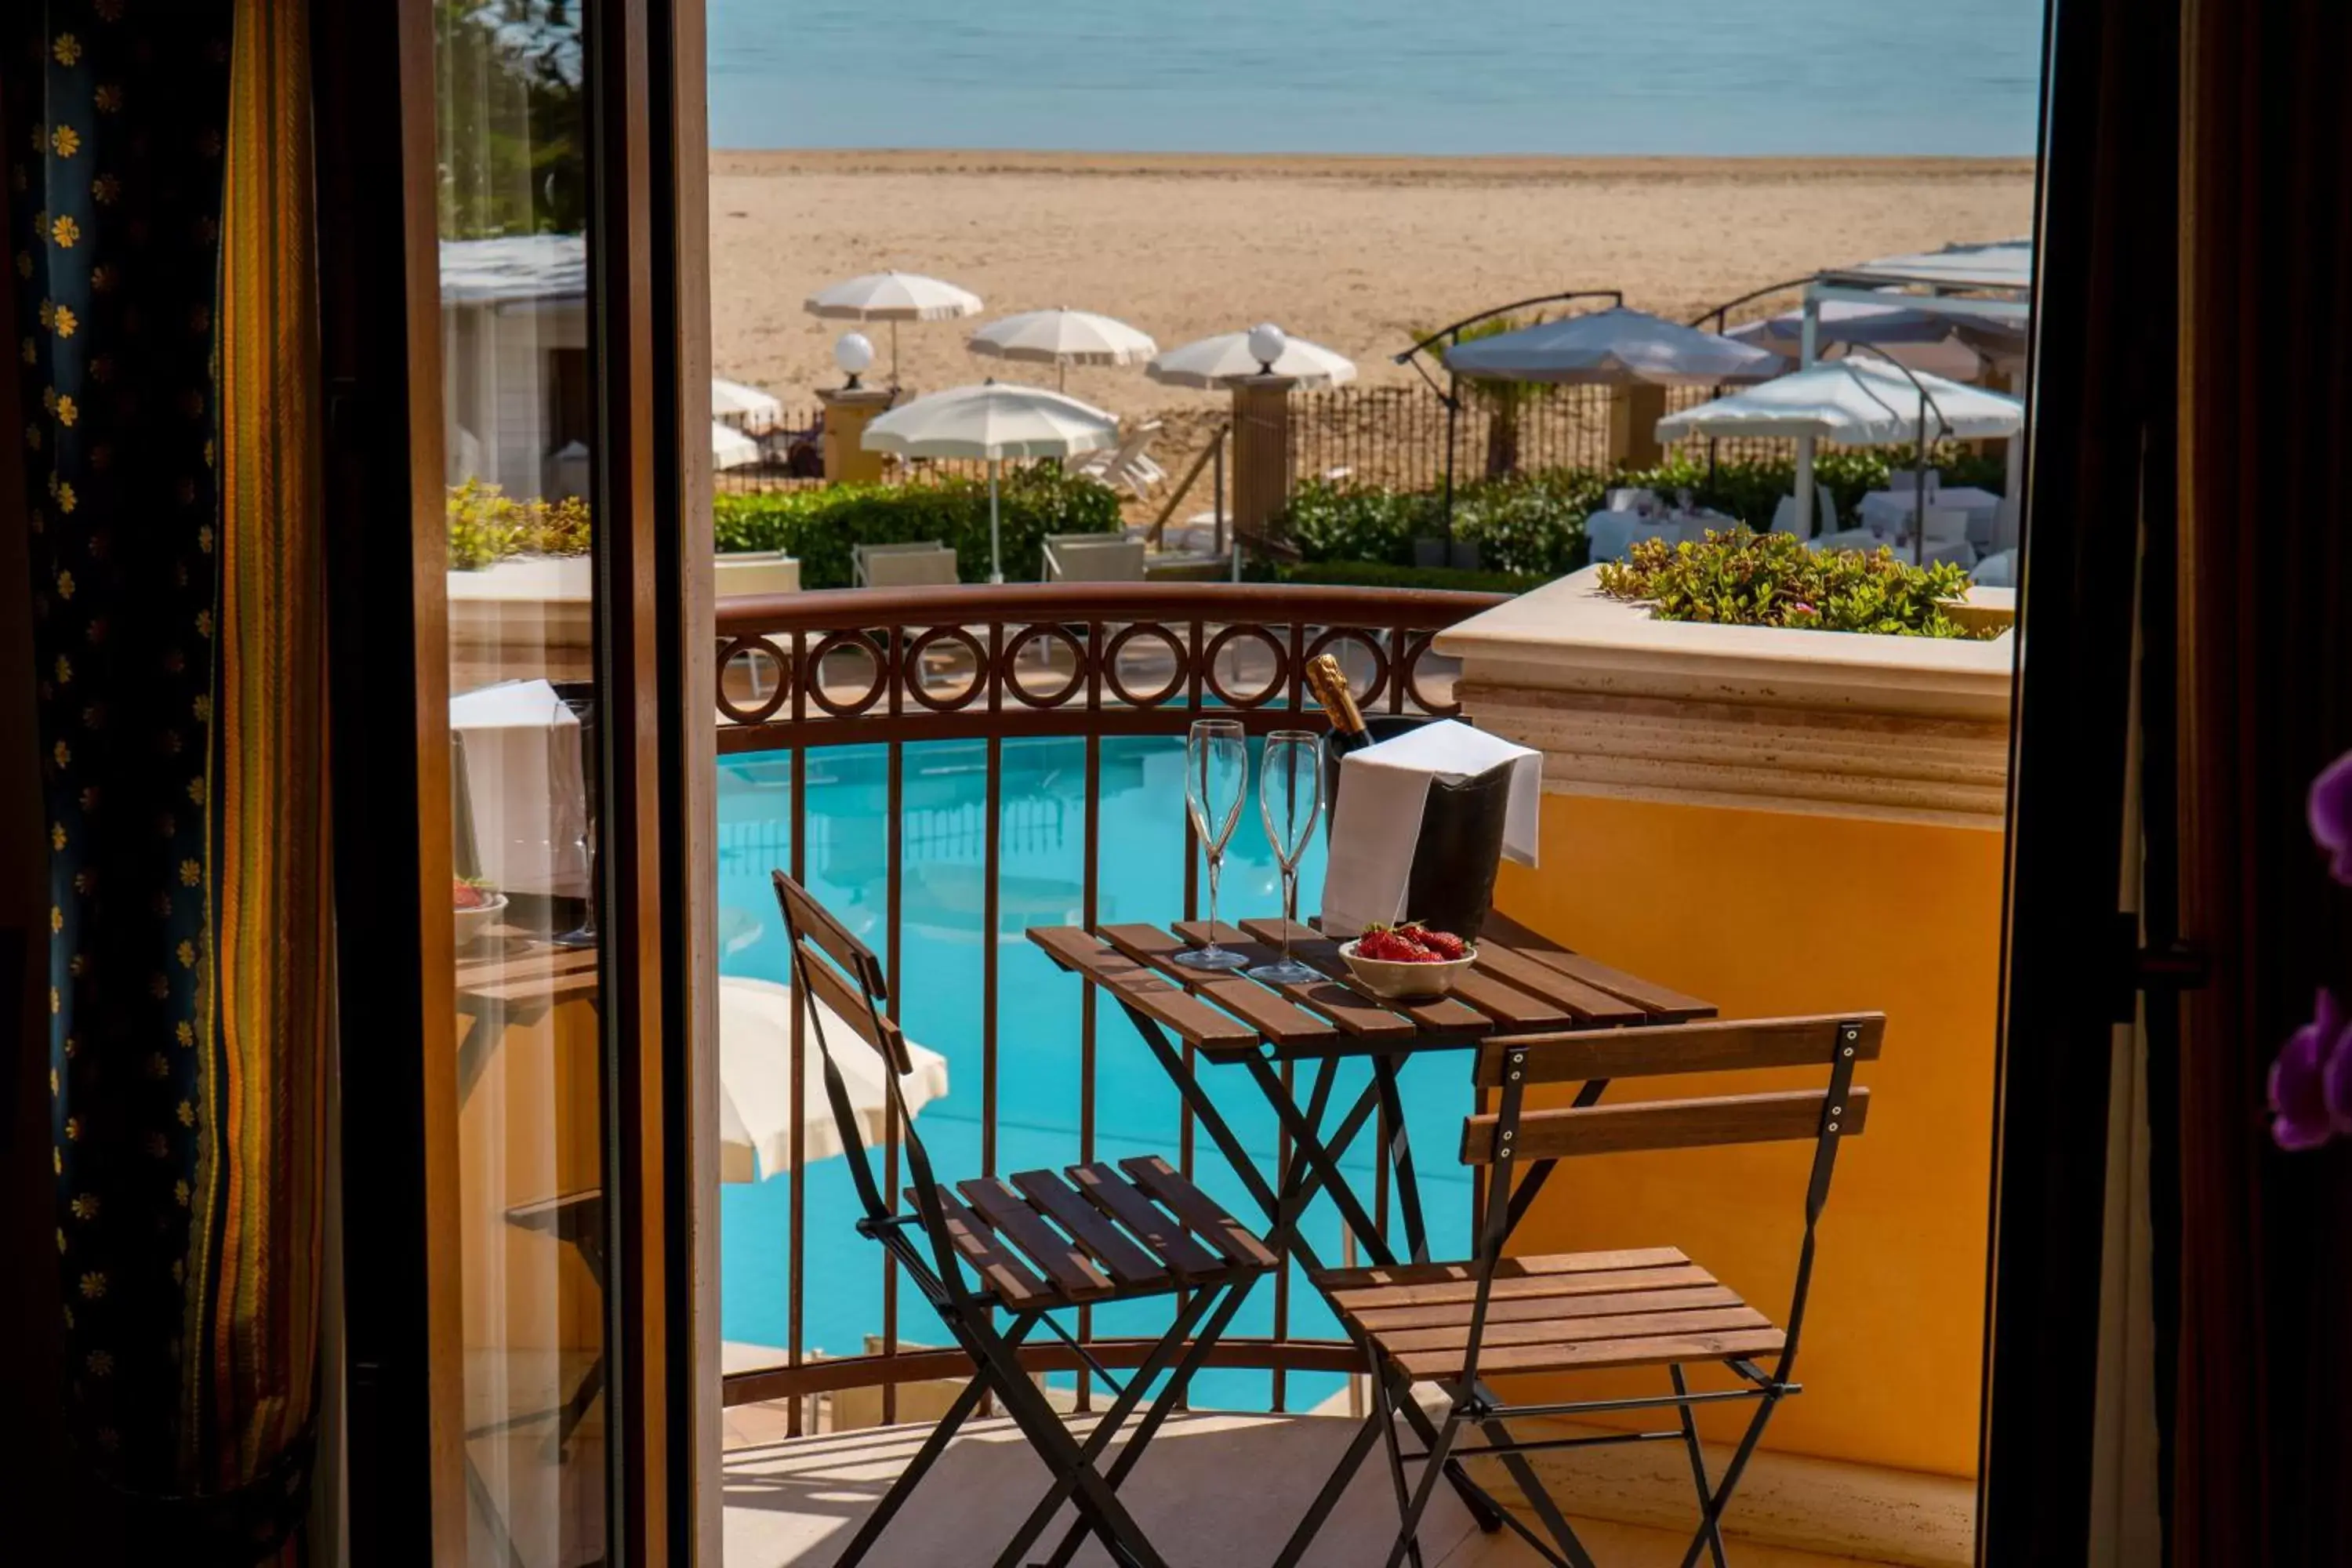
[717,583,1501,1432]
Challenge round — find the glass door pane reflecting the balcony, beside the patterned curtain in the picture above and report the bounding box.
[433,0,607,1568]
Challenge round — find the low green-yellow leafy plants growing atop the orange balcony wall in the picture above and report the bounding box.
[1599,529,1997,640]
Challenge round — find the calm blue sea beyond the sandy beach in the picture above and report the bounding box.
[708,0,2044,158]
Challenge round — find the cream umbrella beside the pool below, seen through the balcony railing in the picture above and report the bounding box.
[720,975,948,1182]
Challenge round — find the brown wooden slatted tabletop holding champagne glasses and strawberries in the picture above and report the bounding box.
[1028,914,1715,1058]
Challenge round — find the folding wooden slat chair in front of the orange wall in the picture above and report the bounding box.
[1312,1013,1886,1568]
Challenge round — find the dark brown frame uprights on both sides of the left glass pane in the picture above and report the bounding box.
[310,0,720,1568]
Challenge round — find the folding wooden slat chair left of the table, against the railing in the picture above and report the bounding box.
[774,872,1275,1568]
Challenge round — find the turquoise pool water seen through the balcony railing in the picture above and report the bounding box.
[720,739,1470,1408]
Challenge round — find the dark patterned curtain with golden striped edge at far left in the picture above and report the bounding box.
[0,0,332,1561]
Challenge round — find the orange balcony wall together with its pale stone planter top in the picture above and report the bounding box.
[1435,569,2016,1523]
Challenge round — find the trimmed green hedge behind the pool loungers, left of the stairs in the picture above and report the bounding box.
[710,463,1120,588]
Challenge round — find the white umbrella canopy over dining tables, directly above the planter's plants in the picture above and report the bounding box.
[1658,360,2025,447]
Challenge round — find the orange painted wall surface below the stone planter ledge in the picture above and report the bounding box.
[1496,794,2002,1476]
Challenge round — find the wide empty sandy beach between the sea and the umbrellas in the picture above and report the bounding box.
[710,151,2032,434]
